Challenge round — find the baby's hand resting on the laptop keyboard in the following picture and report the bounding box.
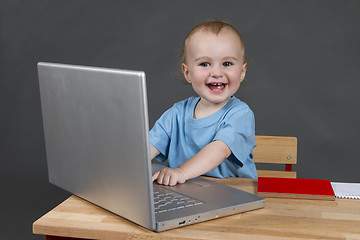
[152,168,186,186]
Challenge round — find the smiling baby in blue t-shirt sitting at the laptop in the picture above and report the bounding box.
[150,20,257,186]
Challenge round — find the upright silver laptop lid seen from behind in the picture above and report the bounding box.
[38,63,155,229]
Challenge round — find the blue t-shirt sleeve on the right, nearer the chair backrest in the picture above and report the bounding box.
[214,107,256,167]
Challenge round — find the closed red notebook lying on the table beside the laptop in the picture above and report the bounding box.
[258,177,335,200]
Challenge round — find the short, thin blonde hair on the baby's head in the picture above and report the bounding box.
[181,20,247,63]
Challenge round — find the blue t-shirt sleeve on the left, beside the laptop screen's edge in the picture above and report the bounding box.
[150,108,173,162]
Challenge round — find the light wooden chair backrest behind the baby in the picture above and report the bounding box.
[253,135,297,178]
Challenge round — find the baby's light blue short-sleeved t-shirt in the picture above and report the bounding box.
[150,96,257,178]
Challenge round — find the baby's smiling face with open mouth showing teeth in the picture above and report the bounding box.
[182,29,247,104]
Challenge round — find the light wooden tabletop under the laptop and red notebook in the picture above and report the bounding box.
[33,178,360,240]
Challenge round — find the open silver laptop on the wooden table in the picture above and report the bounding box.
[38,62,266,232]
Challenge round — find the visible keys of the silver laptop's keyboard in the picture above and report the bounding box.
[153,184,204,213]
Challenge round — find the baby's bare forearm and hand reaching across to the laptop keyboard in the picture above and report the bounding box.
[153,141,231,186]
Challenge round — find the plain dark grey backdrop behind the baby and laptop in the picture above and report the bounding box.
[0,0,360,239]
